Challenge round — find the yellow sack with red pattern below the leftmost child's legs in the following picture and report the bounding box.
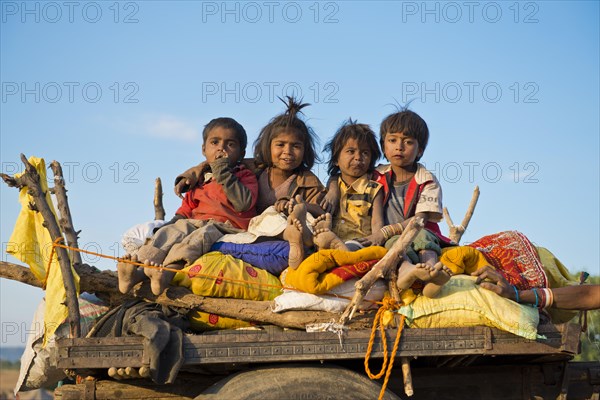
[172,251,281,301]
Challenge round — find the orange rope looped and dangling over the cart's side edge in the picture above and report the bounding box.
[365,297,405,400]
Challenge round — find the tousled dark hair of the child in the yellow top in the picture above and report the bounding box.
[323,119,381,176]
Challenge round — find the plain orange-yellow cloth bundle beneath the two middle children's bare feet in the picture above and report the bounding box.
[285,246,387,294]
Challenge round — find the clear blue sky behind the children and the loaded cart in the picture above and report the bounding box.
[0,1,600,346]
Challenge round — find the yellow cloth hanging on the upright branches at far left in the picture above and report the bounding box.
[6,157,79,345]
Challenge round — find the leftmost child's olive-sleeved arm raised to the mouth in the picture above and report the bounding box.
[210,157,258,212]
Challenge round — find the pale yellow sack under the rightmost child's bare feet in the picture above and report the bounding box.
[398,275,539,340]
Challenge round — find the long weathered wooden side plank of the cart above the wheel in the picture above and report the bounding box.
[56,325,579,369]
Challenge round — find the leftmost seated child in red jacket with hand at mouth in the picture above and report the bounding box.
[117,118,258,295]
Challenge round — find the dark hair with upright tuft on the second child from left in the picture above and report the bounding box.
[254,96,319,171]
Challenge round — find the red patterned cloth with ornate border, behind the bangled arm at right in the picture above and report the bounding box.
[468,231,548,290]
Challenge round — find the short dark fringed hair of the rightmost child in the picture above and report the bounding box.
[379,108,429,161]
